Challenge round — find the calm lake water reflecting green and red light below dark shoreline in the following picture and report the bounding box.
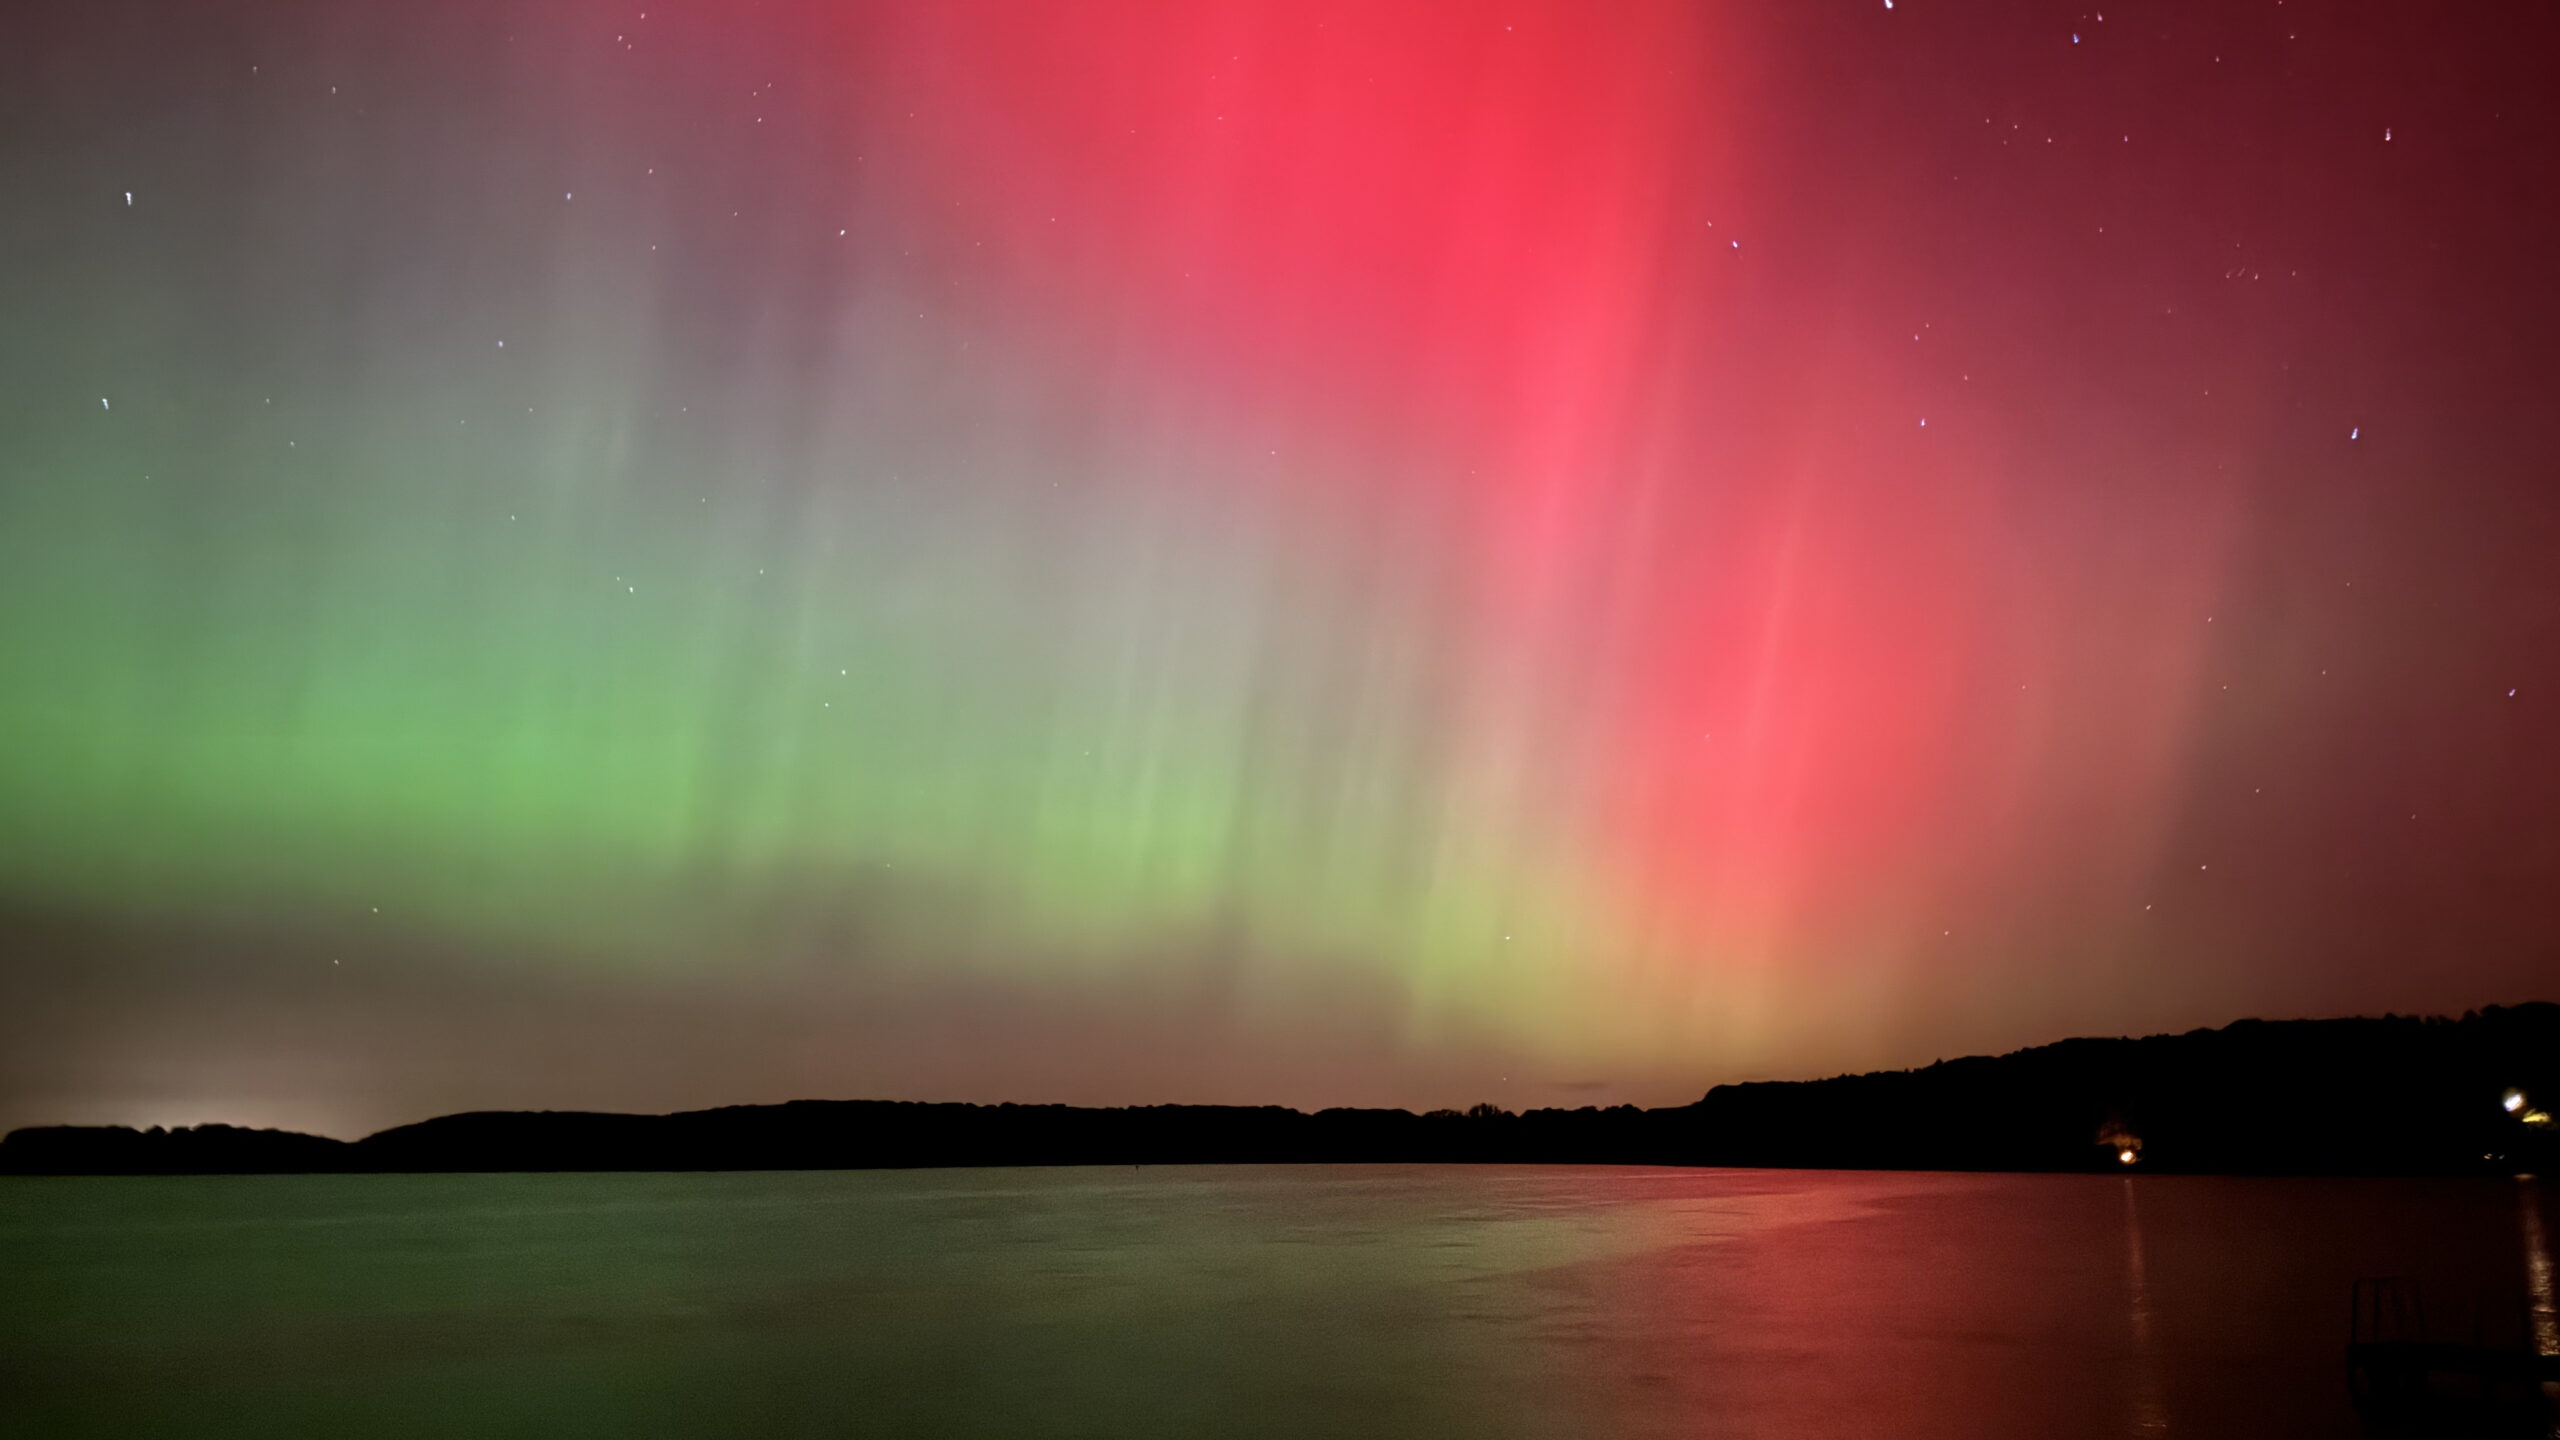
[0,1166,2560,1440]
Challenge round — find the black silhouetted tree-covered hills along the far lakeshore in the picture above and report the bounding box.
[0,1002,2560,1176]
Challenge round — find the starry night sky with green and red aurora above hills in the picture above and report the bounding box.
[0,0,2560,1135]
